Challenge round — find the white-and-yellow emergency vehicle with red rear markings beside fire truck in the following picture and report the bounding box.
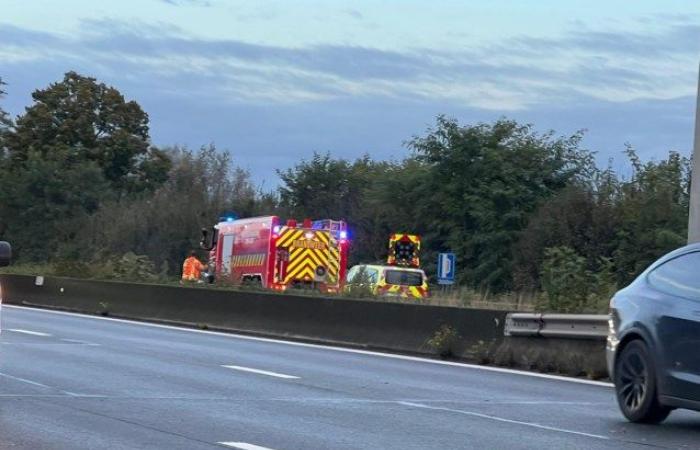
[345,264,429,299]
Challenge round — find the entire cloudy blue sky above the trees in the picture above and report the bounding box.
[0,0,700,187]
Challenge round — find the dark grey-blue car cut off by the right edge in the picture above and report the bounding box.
[607,244,700,423]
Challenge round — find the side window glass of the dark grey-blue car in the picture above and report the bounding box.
[647,252,700,301]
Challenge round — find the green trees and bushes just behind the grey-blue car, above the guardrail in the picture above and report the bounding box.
[514,147,690,290]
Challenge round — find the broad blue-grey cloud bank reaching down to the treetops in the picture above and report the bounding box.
[0,17,700,181]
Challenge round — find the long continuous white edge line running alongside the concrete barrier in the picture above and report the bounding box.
[3,305,613,388]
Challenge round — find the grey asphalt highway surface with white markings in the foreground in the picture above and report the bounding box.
[0,306,700,450]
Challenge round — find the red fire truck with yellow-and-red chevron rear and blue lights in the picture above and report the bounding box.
[201,216,350,293]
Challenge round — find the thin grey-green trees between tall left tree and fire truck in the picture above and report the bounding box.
[79,145,275,275]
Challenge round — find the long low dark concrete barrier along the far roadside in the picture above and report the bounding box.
[0,275,506,360]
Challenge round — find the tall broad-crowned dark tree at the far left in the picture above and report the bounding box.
[0,72,171,262]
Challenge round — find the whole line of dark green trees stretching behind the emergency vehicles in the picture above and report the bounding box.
[0,72,690,310]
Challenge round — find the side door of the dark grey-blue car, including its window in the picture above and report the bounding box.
[647,252,700,401]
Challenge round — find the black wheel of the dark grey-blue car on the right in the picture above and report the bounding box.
[614,340,671,423]
